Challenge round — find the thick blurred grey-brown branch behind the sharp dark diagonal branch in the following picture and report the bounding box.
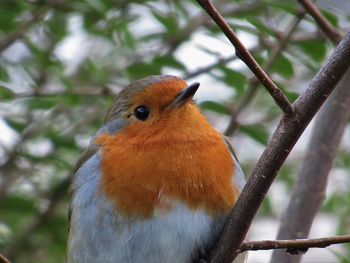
[271,70,350,263]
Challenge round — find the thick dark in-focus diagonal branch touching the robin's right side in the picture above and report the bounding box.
[209,32,350,262]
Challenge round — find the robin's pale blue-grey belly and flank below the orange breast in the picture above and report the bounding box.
[68,152,232,263]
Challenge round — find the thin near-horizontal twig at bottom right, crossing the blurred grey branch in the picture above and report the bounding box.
[238,235,350,254]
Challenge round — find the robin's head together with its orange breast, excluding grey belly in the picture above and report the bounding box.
[95,76,238,217]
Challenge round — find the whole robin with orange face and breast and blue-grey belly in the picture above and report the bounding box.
[67,75,246,263]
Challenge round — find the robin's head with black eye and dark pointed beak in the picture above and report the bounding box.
[106,75,199,133]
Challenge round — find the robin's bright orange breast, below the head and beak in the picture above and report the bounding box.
[96,105,238,218]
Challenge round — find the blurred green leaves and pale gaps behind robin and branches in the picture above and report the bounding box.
[0,0,350,263]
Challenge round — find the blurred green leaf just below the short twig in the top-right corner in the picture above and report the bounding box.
[296,40,327,62]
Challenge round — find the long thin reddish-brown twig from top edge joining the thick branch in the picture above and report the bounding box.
[197,0,294,116]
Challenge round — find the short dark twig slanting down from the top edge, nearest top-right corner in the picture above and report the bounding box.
[298,0,342,44]
